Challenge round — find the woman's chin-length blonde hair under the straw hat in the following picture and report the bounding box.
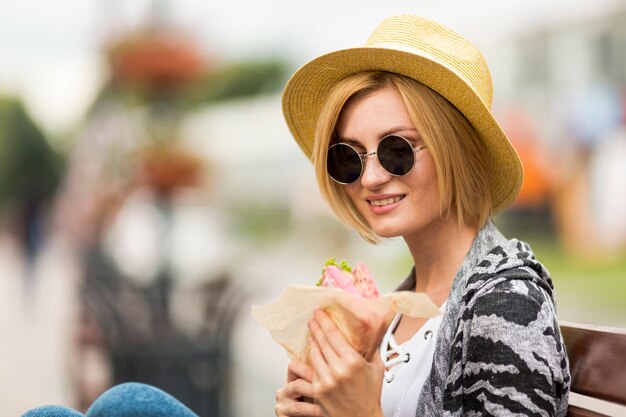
[312,71,493,243]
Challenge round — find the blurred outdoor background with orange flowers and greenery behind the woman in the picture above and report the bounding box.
[0,0,626,417]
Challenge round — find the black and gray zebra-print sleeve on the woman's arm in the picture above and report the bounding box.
[462,280,567,416]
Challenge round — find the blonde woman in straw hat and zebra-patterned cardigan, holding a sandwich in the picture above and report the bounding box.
[275,15,570,417]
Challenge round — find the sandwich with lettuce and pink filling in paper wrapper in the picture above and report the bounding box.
[252,258,440,363]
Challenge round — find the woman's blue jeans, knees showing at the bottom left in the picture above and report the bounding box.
[22,382,198,417]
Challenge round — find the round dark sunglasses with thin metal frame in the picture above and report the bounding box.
[326,135,426,184]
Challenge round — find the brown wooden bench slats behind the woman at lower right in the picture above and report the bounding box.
[560,322,626,417]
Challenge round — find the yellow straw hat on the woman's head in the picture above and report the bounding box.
[283,15,523,213]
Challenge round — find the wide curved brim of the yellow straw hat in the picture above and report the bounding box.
[282,47,523,214]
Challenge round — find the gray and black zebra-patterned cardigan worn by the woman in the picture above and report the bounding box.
[402,222,570,417]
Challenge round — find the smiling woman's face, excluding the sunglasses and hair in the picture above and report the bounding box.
[337,86,442,240]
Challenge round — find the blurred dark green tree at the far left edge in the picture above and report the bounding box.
[0,98,63,208]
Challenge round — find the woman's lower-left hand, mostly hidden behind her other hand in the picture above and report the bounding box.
[274,359,324,417]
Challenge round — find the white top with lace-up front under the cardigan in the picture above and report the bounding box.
[380,300,447,417]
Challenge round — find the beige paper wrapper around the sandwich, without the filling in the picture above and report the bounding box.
[252,285,441,362]
